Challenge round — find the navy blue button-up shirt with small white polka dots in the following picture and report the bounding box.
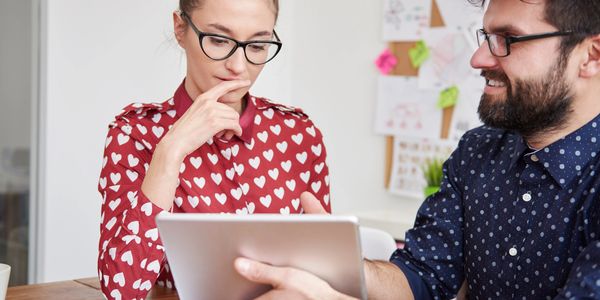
[391,116,600,299]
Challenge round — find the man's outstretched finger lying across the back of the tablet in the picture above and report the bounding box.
[234,257,286,287]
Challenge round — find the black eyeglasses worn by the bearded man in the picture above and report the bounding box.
[477,29,574,57]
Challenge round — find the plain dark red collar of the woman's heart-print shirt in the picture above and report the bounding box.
[173,79,256,144]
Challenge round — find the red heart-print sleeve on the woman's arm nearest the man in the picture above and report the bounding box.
[306,121,331,213]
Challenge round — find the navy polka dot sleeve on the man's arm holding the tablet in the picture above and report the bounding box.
[390,138,464,299]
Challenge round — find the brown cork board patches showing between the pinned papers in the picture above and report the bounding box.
[385,0,454,188]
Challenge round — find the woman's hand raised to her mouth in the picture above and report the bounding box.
[161,80,250,159]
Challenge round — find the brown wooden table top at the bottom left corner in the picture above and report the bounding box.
[6,277,179,300]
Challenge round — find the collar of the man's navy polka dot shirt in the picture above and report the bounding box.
[533,115,600,188]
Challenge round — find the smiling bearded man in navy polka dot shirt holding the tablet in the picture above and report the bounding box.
[235,0,600,299]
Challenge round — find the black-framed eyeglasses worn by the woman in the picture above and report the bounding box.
[181,12,282,65]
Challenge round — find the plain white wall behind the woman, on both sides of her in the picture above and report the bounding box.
[37,0,418,282]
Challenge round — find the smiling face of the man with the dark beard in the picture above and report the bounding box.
[471,0,572,137]
